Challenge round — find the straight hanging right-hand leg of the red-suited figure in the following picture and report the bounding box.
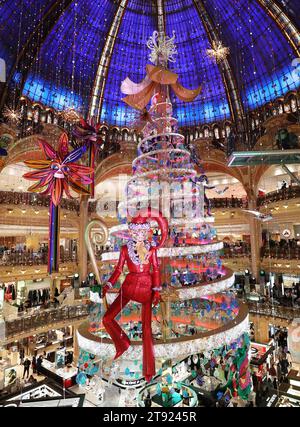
[142,301,155,381]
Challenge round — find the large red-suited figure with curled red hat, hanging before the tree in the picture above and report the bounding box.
[103,209,168,382]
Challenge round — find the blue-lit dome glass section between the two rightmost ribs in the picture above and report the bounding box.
[204,0,299,110]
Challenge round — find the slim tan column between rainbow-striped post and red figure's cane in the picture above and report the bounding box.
[78,196,89,280]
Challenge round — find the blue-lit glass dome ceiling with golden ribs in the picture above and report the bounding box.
[0,0,300,126]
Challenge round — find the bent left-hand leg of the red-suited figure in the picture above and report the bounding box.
[103,294,130,359]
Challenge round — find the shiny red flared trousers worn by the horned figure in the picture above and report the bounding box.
[103,273,155,380]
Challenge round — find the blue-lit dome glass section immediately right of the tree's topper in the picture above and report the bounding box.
[166,0,229,125]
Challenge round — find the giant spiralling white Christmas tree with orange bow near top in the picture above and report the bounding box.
[78,33,251,406]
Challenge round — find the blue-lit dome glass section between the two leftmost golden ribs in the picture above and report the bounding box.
[23,0,116,111]
